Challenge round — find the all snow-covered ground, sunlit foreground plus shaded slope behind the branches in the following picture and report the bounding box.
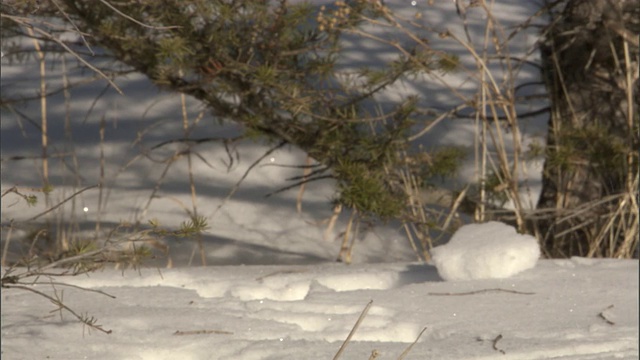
[0,0,639,359]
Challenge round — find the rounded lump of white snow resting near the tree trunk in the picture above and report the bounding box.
[431,221,540,281]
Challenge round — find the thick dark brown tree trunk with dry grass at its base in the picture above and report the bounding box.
[538,0,640,257]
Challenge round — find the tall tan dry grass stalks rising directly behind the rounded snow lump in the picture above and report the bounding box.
[348,2,540,260]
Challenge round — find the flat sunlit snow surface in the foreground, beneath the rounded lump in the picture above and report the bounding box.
[2,258,639,360]
